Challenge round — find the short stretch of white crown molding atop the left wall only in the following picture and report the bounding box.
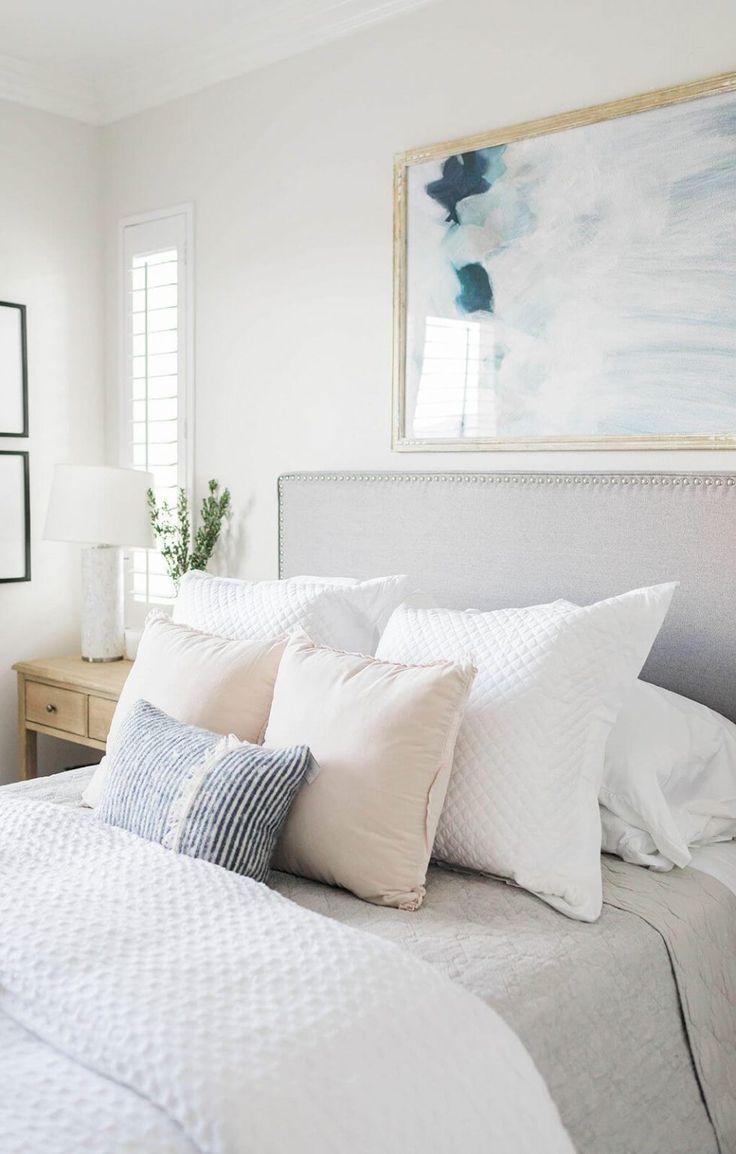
[0,53,102,125]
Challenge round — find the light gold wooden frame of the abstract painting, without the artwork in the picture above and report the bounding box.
[392,73,736,452]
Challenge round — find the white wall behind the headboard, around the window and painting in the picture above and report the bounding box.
[105,0,736,576]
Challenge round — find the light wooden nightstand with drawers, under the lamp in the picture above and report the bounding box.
[13,657,133,778]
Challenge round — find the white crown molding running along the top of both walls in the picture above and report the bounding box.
[0,0,433,125]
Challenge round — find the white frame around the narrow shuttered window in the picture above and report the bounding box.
[117,202,195,625]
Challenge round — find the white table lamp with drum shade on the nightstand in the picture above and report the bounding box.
[44,465,153,661]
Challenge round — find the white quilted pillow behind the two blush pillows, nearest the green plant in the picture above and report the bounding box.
[173,570,412,654]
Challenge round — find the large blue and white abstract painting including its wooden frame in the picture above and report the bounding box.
[393,74,736,451]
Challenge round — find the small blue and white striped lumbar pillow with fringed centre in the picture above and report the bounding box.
[97,700,311,882]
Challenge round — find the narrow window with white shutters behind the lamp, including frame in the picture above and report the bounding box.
[120,207,191,624]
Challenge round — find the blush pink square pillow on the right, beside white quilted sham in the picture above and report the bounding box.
[264,635,475,909]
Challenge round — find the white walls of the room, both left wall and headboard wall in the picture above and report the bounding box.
[0,0,736,777]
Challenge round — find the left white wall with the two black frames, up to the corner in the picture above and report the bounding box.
[0,102,104,781]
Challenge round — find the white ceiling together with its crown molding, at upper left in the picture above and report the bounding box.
[0,0,429,123]
